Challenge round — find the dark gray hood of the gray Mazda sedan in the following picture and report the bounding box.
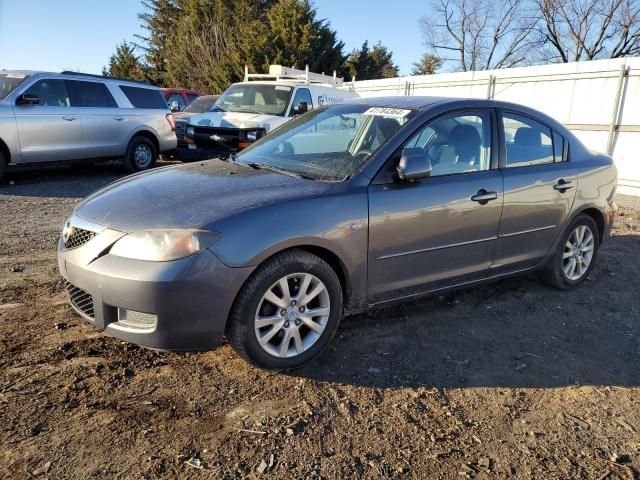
[75,160,332,232]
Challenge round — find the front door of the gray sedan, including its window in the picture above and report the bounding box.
[368,109,503,303]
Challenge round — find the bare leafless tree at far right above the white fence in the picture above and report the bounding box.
[536,0,640,62]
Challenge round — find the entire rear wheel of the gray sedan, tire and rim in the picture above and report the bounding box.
[544,215,600,290]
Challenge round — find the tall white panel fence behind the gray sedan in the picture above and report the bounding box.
[355,57,640,195]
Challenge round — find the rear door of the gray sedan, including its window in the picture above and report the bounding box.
[494,110,578,267]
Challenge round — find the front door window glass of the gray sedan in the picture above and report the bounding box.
[404,112,491,177]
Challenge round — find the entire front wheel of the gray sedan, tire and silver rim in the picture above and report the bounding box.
[227,250,342,370]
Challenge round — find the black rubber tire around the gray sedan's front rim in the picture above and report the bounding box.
[226,249,343,370]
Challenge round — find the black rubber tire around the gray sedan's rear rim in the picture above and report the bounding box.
[542,214,600,290]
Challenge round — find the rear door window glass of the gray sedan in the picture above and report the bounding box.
[502,112,554,168]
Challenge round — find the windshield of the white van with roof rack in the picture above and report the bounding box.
[213,83,293,115]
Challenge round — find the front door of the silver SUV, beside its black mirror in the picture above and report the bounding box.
[14,78,85,162]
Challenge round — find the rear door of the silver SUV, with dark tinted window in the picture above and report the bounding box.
[67,80,131,158]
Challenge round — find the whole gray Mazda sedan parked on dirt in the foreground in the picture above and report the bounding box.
[58,97,617,369]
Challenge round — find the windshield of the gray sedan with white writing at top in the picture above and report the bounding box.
[236,104,415,181]
